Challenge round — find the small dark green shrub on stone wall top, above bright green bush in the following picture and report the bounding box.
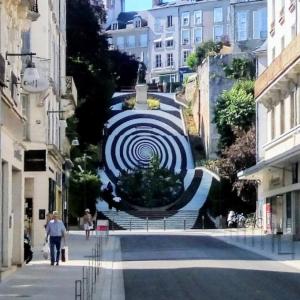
[223,58,255,80]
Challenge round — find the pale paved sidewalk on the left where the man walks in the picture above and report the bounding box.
[0,231,115,300]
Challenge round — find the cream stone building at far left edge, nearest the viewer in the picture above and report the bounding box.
[0,0,39,272]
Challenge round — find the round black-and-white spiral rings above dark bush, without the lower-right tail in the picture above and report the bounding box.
[103,95,194,183]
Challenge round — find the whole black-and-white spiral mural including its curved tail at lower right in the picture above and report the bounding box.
[100,94,216,226]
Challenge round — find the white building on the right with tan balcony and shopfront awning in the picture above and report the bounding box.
[239,0,300,239]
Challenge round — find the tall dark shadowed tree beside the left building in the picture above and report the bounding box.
[67,0,137,145]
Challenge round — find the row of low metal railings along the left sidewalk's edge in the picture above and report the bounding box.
[75,236,107,300]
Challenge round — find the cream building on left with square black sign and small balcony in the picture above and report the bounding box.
[21,0,77,246]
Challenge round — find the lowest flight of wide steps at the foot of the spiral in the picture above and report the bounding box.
[101,210,199,230]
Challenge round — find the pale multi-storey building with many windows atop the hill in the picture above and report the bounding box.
[108,0,267,82]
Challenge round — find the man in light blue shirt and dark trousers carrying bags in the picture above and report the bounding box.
[46,211,66,266]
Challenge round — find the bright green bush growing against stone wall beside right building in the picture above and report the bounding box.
[215,80,255,149]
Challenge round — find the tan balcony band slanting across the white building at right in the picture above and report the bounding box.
[255,35,300,98]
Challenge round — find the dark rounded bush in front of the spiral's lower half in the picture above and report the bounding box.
[117,157,183,208]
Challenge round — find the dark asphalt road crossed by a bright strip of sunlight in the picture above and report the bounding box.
[120,234,300,300]
